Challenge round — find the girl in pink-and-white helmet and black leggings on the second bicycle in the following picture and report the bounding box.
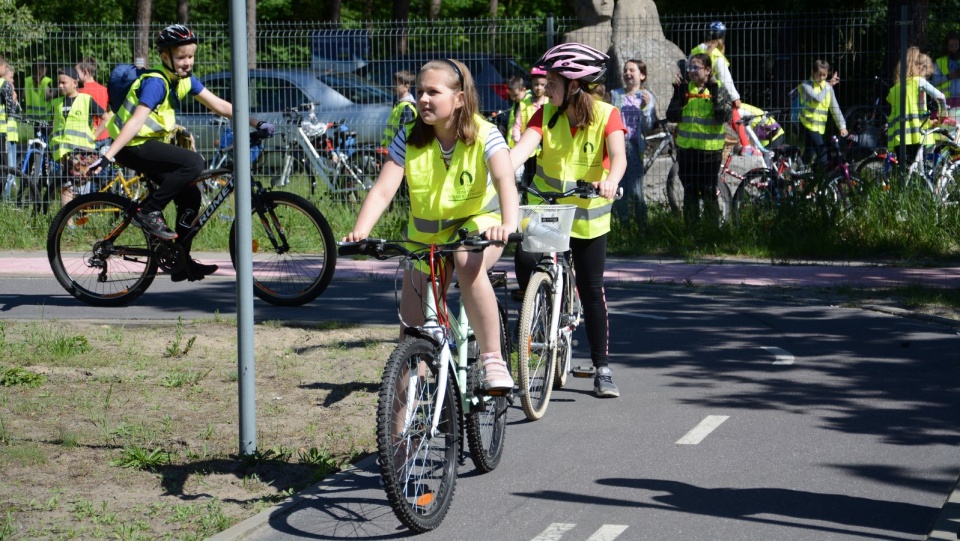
[510,43,627,397]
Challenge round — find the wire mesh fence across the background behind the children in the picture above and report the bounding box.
[0,7,949,217]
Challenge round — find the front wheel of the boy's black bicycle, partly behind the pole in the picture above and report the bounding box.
[230,192,337,306]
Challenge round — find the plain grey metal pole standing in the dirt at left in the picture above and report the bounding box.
[230,0,257,455]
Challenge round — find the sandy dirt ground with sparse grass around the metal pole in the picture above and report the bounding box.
[0,286,960,540]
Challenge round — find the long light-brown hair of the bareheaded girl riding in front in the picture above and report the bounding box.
[407,58,480,148]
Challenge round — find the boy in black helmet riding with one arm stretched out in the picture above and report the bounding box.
[87,24,274,282]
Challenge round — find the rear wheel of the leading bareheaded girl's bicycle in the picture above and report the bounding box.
[466,303,510,473]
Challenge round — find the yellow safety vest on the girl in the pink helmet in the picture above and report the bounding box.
[529,99,614,239]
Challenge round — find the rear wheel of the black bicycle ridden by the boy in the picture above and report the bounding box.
[47,192,158,306]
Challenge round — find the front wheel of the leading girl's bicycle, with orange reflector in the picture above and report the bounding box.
[377,338,460,532]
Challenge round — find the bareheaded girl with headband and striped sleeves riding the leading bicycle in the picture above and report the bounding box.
[343,59,529,390]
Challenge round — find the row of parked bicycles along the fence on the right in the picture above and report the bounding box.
[645,107,960,220]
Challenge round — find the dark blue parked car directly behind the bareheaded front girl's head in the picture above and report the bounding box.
[356,52,527,114]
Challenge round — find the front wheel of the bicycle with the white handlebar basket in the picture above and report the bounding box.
[517,272,555,421]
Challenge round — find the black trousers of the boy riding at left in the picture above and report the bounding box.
[117,140,206,252]
